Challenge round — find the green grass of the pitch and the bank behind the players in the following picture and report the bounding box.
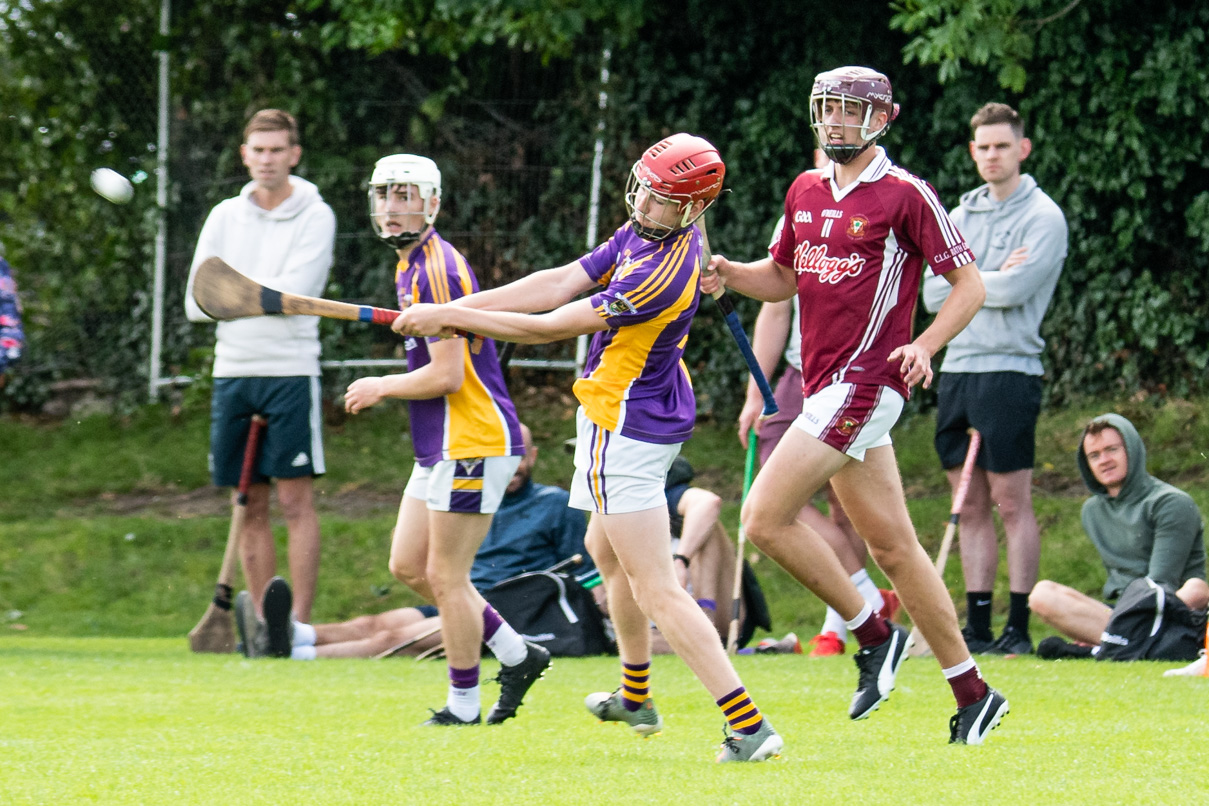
[0,389,1209,806]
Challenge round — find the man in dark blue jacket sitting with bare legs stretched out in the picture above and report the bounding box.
[245,423,598,660]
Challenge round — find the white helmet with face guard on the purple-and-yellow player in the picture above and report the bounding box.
[368,153,441,249]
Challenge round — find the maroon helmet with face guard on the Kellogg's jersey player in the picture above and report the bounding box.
[810,68,898,166]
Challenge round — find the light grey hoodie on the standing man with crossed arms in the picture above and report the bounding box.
[924,174,1066,376]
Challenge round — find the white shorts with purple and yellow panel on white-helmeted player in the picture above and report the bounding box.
[403,457,521,515]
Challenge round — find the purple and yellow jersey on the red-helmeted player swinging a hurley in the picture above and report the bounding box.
[574,224,701,445]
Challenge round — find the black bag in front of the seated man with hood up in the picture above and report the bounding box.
[1095,576,1205,661]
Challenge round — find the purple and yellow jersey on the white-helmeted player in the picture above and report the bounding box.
[394,231,525,468]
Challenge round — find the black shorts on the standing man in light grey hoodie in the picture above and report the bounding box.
[935,372,1041,472]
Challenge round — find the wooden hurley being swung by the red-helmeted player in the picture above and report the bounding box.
[193,257,482,353]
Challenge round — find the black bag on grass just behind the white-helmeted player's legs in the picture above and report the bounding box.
[482,572,615,657]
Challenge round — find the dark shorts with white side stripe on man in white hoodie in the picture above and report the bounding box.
[210,376,325,487]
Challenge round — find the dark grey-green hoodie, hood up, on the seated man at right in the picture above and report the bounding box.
[1076,414,1205,599]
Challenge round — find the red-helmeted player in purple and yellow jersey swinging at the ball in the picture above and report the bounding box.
[394,133,783,761]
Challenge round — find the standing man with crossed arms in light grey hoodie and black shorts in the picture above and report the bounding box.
[924,104,1066,655]
